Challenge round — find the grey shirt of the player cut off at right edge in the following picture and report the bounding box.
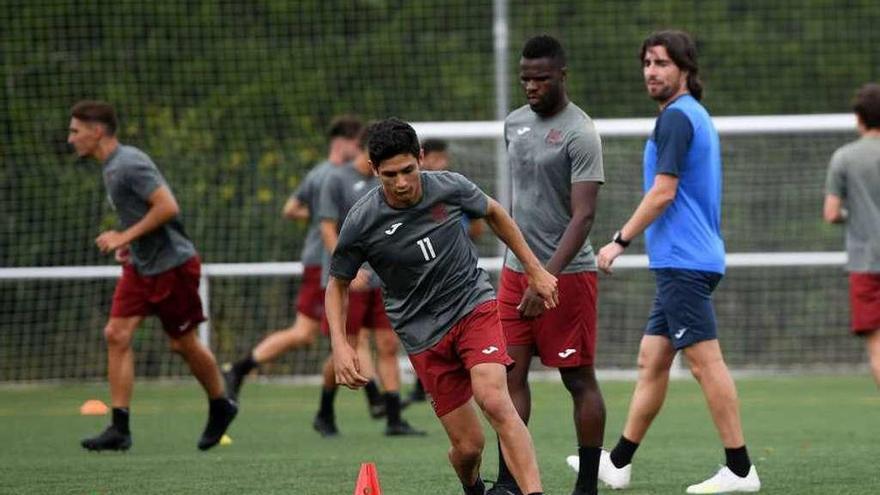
[825,137,880,273]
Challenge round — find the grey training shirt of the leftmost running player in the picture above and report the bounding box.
[103,144,196,275]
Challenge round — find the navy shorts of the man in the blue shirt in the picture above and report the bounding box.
[645,268,722,350]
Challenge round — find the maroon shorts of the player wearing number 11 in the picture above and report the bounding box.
[409,301,513,418]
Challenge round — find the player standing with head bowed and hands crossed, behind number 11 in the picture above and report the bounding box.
[490,35,605,495]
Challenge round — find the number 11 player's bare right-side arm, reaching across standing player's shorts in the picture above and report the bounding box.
[485,198,559,308]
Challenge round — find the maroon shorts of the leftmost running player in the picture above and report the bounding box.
[110,256,206,337]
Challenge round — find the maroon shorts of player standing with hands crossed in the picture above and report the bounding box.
[498,268,598,368]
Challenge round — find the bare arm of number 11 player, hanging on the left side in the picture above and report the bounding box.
[324,275,368,388]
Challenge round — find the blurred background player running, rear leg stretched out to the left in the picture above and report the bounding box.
[224,116,385,417]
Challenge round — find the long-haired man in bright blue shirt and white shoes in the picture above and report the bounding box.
[599,31,761,493]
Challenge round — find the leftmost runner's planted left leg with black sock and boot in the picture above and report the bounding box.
[80,316,143,451]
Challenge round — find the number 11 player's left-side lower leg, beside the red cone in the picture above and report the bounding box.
[440,401,486,495]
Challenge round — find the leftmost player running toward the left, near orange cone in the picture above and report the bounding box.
[67,101,238,450]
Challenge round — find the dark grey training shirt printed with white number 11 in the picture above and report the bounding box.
[330,172,495,354]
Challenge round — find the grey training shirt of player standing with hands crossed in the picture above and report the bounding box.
[504,103,605,273]
